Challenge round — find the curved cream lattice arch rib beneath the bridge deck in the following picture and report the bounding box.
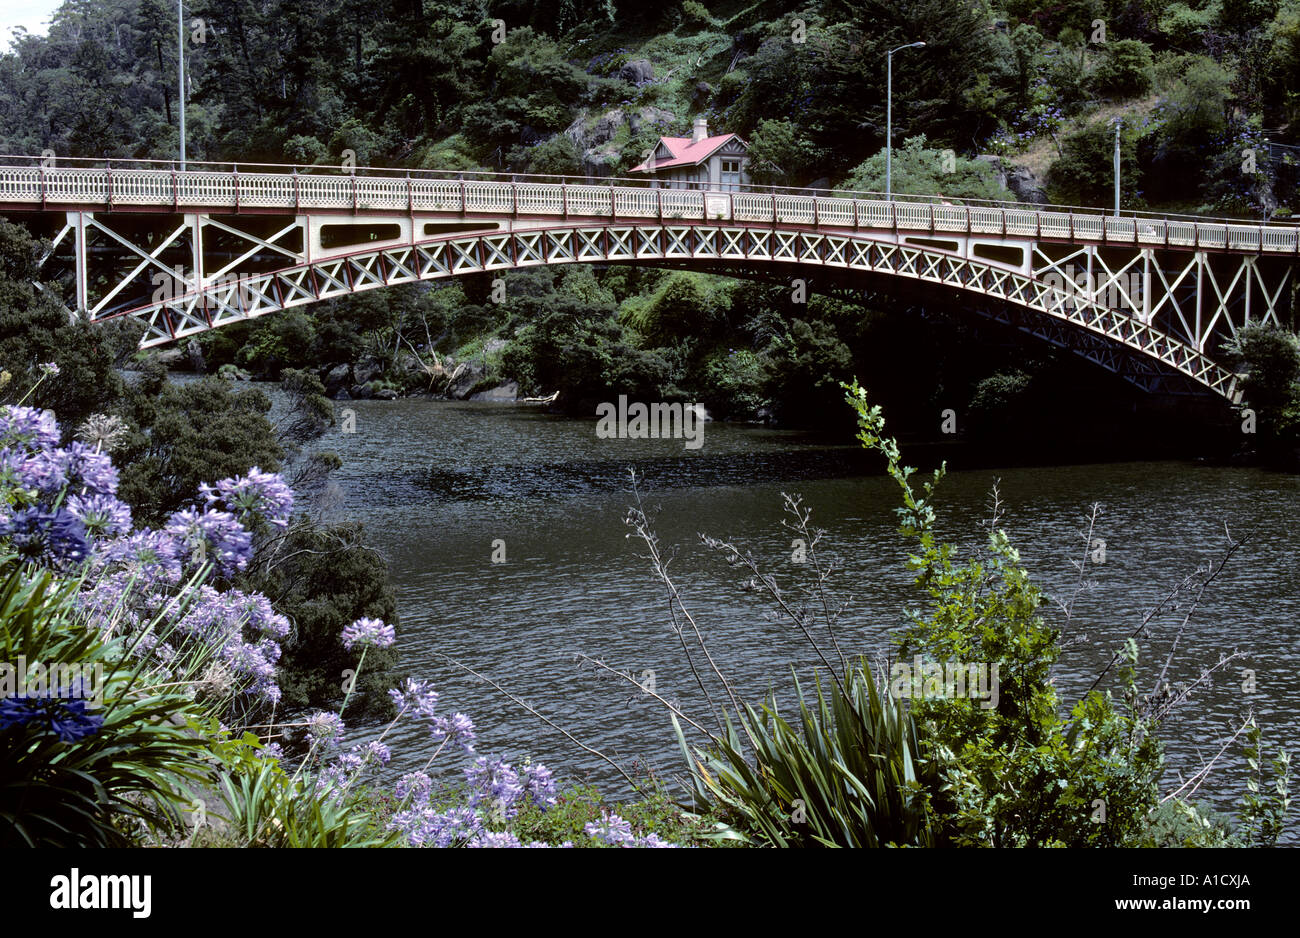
[109,220,1240,403]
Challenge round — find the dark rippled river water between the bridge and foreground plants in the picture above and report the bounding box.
[287,389,1300,842]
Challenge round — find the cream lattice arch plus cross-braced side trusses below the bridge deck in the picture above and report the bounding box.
[45,213,1291,401]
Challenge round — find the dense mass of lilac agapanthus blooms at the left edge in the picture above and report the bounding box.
[0,407,293,704]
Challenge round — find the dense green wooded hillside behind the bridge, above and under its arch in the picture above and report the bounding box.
[0,0,1300,446]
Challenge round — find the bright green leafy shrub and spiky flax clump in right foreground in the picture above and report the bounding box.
[665,383,1290,847]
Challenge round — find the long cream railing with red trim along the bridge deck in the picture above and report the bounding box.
[0,157,1300,255]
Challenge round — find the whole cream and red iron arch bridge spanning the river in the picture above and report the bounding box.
[0,157,1300,403]
